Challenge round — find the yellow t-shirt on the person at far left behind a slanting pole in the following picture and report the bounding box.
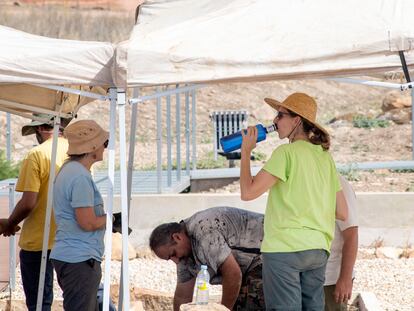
[16,137,68,251]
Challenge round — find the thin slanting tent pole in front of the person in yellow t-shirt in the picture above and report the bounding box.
[36,106,62,311]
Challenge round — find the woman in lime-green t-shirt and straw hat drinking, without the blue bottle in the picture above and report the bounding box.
[240,93,347,310]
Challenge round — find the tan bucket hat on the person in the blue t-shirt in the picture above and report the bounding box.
[64,120,109,155]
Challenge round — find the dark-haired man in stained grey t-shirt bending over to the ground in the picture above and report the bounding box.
[150,207,265,311]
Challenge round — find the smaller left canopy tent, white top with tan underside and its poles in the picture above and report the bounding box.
[0,26,133,310]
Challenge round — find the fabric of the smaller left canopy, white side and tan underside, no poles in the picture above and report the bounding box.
[0,26,114,114]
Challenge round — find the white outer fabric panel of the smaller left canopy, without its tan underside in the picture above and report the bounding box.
[0,26,114,86]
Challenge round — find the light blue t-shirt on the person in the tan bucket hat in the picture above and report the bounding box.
[50,161,105,263]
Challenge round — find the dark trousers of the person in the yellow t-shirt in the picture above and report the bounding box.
[20,250,53,311]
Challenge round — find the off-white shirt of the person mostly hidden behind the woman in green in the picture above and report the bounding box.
[325,176,358,286]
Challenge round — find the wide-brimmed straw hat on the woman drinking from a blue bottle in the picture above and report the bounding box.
[264,93,329,136]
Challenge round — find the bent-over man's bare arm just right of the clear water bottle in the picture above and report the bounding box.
[220,254,242,310]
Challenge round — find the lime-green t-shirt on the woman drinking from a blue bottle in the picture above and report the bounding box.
[261,140,341,253]
